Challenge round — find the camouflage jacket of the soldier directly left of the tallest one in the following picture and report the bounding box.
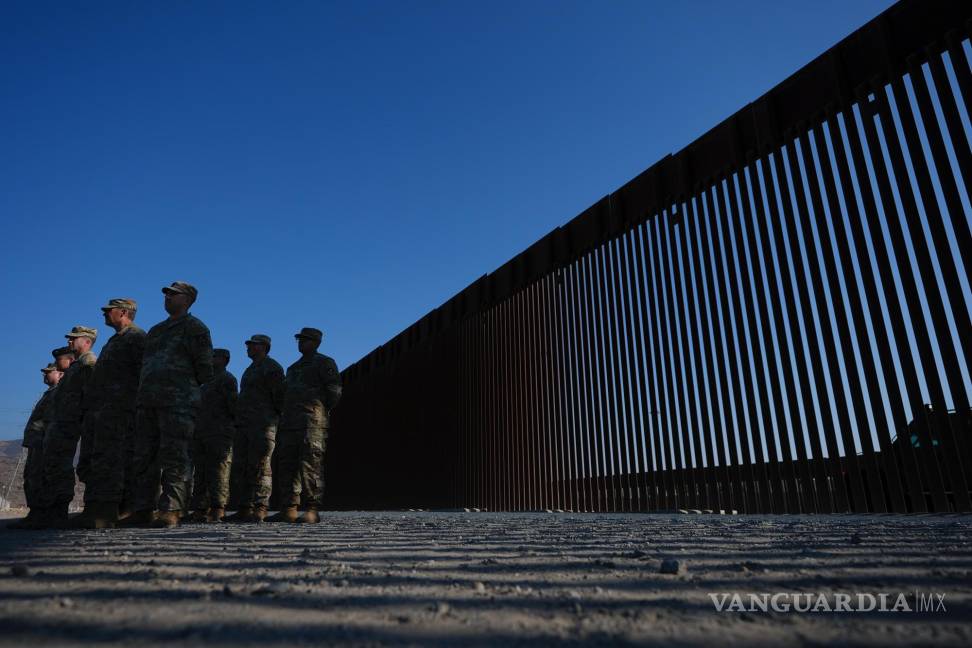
[84,324,145,413]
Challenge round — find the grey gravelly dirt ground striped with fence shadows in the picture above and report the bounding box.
[0,512,972,646]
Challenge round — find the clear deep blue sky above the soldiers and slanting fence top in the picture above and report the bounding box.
[0,0,891,439]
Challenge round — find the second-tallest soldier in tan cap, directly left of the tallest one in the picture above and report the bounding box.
[71,298,145,529]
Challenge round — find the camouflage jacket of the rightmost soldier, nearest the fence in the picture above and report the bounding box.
[280,353,341,429]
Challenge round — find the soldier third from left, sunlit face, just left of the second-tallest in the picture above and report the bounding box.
[35,326,98,529]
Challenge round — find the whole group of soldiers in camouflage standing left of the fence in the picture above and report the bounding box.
[8,281,341,529]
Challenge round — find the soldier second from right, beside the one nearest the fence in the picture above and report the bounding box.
[230,334,284,522]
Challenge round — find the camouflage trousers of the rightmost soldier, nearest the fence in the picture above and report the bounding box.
[276,427,327,507]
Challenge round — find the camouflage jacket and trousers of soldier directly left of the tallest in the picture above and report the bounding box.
[84,324,145,510]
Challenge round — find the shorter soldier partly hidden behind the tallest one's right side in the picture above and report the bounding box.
[192,349,237,522]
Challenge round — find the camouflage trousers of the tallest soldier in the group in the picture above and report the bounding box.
[135,407,196,511]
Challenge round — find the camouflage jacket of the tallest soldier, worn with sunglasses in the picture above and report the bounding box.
[135,313,213,409]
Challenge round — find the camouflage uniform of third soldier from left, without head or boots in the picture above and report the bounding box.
[40,344,97,507]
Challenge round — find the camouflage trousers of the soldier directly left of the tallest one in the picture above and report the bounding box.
[78,412,135,510]
